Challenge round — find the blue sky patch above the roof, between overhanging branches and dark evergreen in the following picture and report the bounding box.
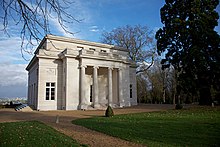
[50,0,164,41]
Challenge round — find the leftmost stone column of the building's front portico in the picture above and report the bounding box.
[80,65,87,109]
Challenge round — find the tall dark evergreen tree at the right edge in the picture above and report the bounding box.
[156,0,220,105]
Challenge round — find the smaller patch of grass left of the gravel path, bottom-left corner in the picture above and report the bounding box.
[0,121,86,146]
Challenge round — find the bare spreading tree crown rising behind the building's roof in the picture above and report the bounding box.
[101,25,156,73]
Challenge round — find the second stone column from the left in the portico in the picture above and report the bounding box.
[92,66,99,108]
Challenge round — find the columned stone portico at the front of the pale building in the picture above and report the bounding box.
[80,65,124,109]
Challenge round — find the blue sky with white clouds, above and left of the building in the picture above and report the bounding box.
[0,0,220,97]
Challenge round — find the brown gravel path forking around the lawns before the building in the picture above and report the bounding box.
[0,105,174,147]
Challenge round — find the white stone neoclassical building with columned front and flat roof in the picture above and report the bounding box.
[26,35,137,110]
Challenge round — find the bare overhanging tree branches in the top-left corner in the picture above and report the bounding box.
[0,0,80,56]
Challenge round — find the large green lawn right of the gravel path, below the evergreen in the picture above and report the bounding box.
[73,108,220,146]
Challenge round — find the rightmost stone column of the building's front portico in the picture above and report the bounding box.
[118,69,124,107]
